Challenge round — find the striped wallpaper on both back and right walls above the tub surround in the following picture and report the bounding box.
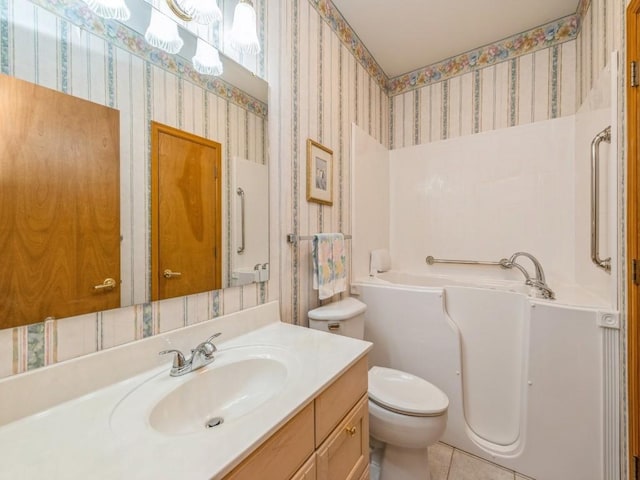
[389,0,624,149]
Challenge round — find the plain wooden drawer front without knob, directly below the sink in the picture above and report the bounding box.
[224,403,315,480]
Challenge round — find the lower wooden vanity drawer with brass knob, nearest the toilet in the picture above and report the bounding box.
[316,394,369,480]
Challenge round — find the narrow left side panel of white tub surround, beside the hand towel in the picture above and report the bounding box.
[351,124,390,278]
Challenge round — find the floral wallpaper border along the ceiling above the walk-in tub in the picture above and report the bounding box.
[309,0,591,96]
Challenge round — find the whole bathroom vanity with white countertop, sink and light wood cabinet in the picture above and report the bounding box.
[0,302,371,480]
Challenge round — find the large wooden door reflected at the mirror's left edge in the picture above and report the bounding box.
[0,75,120,328]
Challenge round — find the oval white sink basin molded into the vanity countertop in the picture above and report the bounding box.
[110,346,297,435]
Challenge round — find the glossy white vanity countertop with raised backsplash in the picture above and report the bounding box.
[0,302,370,480]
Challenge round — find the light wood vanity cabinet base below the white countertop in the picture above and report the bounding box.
[224,358,369,480]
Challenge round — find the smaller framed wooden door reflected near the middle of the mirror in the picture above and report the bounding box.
[151,122,222,300]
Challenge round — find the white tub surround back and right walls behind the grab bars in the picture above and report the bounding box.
[390,105,618,305]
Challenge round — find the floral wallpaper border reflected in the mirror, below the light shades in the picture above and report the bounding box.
[30,0,267,118]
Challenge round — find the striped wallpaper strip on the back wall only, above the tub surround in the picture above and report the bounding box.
[391,40,576,148]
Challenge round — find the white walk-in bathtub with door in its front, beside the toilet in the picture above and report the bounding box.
[355,279,620,480]
